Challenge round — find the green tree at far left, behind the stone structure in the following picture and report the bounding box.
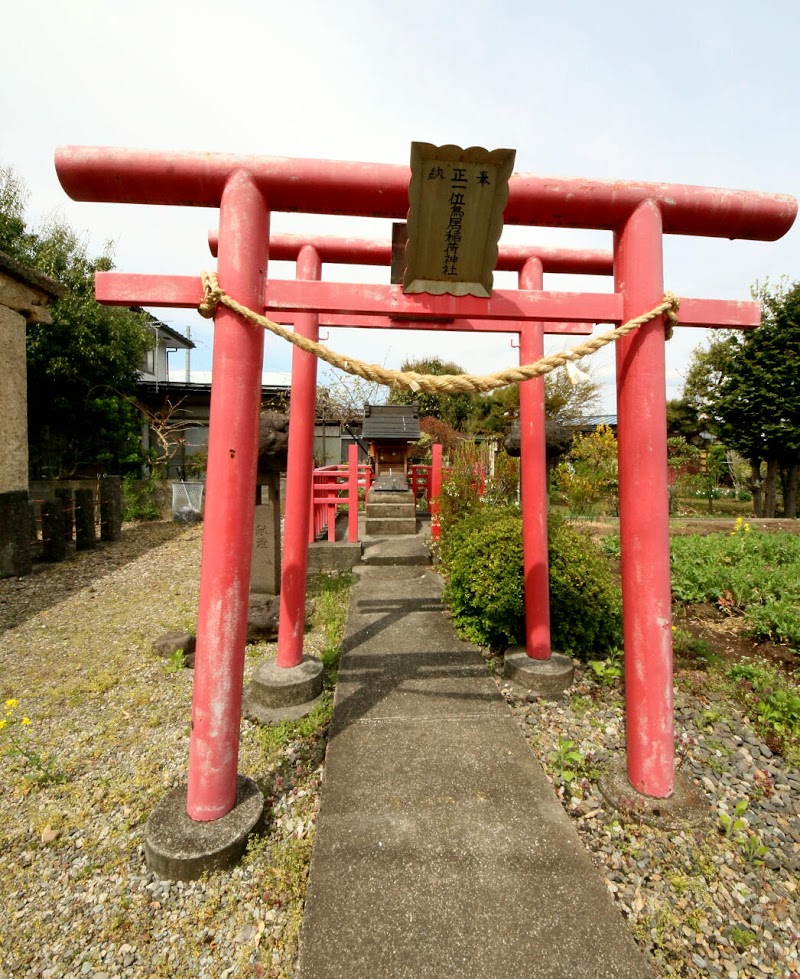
[0,167,153,478]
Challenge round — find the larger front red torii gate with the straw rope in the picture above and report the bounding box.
[56,147,797,876]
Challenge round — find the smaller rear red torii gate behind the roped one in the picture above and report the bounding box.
[211,235,613,668]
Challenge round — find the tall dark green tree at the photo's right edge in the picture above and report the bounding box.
[687,282,800,517]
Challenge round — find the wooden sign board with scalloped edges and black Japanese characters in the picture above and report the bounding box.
[403,143,516,298]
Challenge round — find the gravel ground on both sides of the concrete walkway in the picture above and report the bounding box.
[0,523,800,979]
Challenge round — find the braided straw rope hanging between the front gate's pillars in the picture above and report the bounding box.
[198,272,680,394]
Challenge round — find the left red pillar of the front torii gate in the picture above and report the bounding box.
[187,173,269,821]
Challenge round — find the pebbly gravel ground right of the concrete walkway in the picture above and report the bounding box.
[500,663,800,979]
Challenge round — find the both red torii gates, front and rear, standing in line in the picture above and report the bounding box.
[56,147,797,844]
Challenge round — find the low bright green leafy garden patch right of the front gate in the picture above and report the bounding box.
[671,518,800,648]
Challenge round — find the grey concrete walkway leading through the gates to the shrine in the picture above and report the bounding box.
[298,537,653,979]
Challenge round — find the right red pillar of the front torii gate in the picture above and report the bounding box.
[615,204,675,798]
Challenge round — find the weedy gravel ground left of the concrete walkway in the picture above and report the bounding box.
[0,523,332,979]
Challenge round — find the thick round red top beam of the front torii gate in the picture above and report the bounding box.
[55,146,797,241]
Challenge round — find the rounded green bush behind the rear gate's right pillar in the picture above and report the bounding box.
[441,506,622,659]
